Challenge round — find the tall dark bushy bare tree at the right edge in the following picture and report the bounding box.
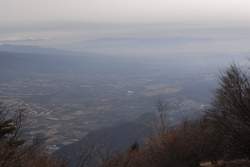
[205,63,250,158]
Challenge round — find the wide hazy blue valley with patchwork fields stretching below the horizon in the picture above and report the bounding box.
[0,45,247,149]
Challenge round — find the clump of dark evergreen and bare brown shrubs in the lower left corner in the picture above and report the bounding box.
[0,103,64,167]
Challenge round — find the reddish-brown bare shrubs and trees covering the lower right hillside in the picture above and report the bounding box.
[98,63,250,167]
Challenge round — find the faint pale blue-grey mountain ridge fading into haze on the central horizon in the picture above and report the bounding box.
[61,37,218,55]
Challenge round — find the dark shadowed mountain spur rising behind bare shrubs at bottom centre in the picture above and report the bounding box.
[53,113,150,166]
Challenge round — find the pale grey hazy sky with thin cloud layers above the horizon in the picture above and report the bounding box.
[0,0,250,51]
